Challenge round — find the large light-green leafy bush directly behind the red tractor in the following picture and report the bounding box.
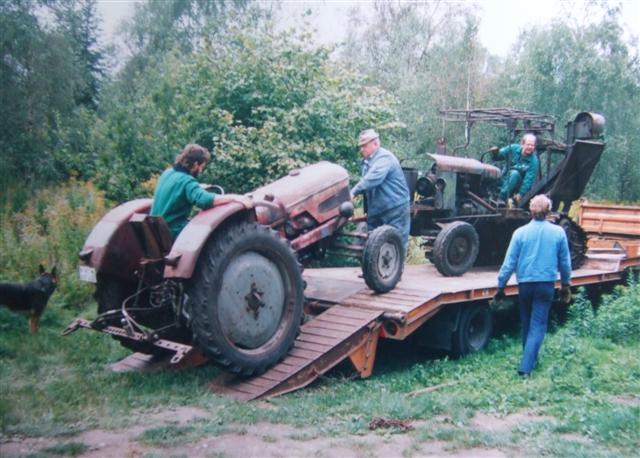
[97,17,396,200]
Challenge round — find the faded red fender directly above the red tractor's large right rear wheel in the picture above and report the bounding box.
[164,202,248,279]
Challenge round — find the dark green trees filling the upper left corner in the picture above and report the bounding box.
[0,0,102,188]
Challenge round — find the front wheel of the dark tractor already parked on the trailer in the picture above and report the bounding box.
[431,221,480,277]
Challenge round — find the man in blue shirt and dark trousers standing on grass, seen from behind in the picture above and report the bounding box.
[495,195,571,377]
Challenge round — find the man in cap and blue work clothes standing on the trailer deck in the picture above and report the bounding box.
[351,129,411,251]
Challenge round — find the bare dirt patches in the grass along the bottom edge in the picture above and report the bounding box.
[0,407,552,458]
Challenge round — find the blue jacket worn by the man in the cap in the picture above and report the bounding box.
[351,148,409,216]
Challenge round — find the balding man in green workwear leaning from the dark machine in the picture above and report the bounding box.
[490,134,540,202]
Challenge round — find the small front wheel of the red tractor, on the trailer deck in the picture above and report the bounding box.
[362,225,404,293]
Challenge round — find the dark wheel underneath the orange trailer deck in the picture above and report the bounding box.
[451,304,493,357]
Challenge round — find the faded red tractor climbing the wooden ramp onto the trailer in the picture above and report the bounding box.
[65,162,404,375]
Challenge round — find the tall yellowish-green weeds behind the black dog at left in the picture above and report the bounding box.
[0,180,105,308]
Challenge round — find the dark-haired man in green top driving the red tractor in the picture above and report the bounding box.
[151,144,253,239]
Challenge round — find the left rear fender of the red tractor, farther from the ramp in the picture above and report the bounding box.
[79,199,152,276]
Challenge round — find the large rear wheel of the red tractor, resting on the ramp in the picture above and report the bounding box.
[186,222,304,375]
